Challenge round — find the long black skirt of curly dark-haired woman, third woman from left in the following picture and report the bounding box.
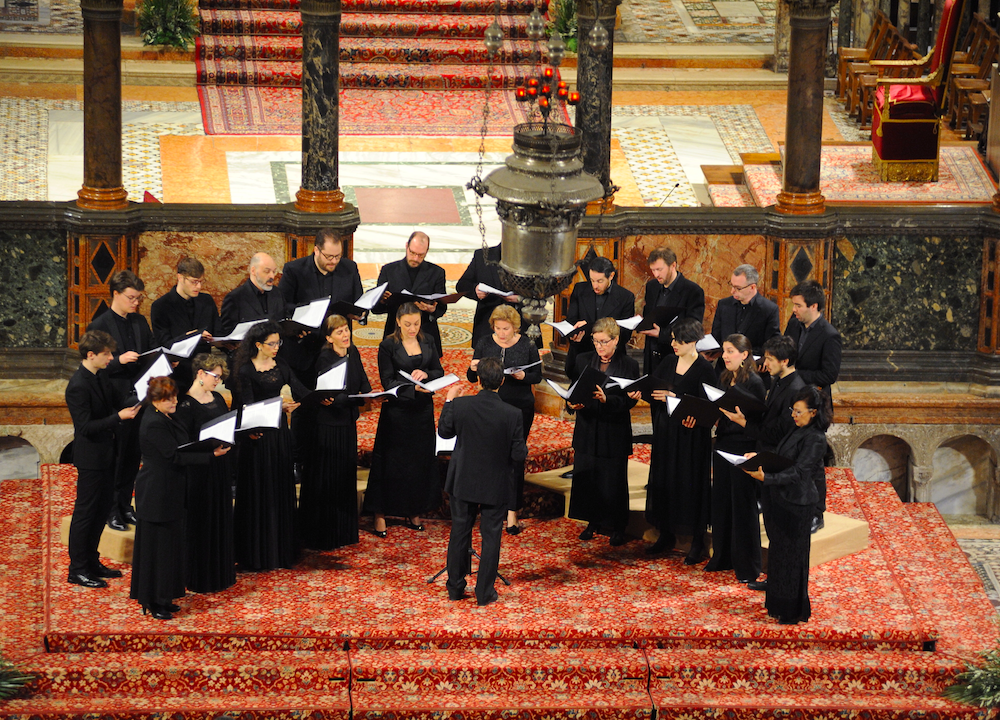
[233,428,296,570]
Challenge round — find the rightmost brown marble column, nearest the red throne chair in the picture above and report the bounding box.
[775,0,832,215]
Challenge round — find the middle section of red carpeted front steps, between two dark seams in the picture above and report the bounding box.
[351,648,652,718]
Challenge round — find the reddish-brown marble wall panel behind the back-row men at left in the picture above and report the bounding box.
[139,232,285,318]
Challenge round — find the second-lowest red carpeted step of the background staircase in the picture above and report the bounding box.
[195,35,536,65]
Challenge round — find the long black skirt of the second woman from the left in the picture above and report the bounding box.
[187,453,236,593]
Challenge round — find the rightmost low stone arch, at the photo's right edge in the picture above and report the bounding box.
[928,433,1000,521]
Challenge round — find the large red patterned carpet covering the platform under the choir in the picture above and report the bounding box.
[0,458,997,718]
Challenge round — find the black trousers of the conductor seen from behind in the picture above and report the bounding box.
[447,496,507,603]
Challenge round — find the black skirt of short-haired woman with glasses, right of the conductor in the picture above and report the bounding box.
[569,450,628,532]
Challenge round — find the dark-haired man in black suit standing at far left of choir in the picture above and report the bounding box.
[66,330,139,588]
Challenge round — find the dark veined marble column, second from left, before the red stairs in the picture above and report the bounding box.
[295,0,344,213]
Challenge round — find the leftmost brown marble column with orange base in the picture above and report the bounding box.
[76,0,128,210]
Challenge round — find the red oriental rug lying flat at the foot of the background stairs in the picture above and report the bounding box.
[198,85,569,137]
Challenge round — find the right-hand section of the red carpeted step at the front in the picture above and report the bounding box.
[646,648,964,696]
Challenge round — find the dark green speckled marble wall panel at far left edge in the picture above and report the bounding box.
[0,230,66,347]
